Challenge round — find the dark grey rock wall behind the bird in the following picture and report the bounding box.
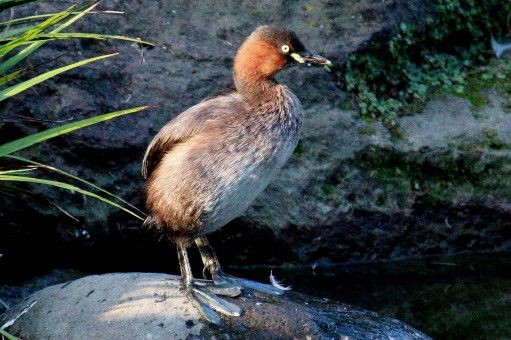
[0,0,511,266]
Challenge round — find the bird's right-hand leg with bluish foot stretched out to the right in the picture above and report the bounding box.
[195,236,284,295]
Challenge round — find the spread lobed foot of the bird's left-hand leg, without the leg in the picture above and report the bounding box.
[184,282,243,325]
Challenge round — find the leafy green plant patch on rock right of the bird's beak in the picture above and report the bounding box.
[342,0,511,127]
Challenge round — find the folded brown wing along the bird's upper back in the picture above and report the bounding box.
[142,91,237,178]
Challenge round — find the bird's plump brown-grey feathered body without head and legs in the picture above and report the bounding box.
[143,85,302,235]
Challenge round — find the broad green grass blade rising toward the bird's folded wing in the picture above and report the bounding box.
[0,106,149,157]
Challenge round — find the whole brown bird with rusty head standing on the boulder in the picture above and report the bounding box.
[142,26,329,322]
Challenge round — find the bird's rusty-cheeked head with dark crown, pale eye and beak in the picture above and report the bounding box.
[234,26,331,81]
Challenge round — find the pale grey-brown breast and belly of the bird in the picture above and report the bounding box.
[204,87,302,232]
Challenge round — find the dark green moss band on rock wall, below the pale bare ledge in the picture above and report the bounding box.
[351,143,511,208]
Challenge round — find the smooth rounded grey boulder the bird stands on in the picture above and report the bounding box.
[0,273,429,339]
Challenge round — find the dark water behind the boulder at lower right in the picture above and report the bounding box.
[229,253,511,339]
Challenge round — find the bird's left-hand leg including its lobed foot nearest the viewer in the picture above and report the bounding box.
[177,242,242,324]
